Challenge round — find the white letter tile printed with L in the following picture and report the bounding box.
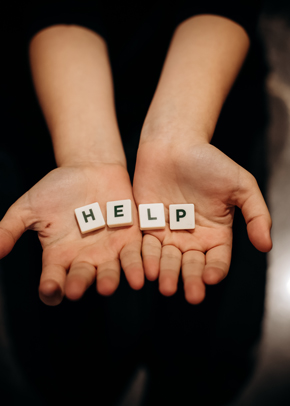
[139,203,165,230]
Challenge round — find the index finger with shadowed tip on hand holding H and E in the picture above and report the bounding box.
[38,264,66,306]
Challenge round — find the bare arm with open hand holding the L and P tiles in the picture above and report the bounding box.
[133,15,272,304]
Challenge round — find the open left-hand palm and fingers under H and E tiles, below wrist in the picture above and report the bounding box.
[0,164,144,305]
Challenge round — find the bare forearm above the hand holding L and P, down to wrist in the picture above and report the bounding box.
[141,15,249,142]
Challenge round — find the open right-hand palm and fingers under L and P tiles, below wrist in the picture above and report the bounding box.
[133,139,272,304]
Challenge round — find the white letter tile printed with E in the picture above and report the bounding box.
[107,199,133,227]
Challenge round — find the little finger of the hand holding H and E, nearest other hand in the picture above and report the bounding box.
[120,241,144,290]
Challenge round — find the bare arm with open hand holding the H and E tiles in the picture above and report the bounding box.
[0,26,144,305]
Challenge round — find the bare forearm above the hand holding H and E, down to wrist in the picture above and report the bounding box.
[30,25,126,166]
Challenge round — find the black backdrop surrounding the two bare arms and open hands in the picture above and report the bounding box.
[0,2,287,406]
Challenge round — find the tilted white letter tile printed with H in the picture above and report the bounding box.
[75,203,106,234]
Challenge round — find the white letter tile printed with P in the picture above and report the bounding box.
[169,204,195,230]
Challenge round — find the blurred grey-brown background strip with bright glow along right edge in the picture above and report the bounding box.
[231,0,290,406]
